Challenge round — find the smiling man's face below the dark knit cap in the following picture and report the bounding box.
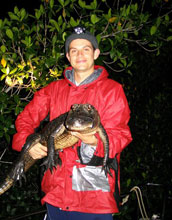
[66,39,100,74]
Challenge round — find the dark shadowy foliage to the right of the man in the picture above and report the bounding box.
[118,40,172,219]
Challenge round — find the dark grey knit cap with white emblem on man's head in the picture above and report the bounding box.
[65,26,99,53]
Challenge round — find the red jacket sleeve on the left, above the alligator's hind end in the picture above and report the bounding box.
[12,84,51,151]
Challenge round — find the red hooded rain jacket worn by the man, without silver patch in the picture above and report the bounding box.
[13,66,132,213]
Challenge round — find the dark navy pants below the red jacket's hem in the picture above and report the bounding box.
[46,204,113,220]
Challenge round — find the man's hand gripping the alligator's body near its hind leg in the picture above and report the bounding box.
[29,143,47,160]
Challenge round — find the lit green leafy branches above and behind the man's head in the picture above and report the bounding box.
[0,0,172,94]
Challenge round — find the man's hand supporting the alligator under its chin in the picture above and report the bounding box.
[71,131,97,146]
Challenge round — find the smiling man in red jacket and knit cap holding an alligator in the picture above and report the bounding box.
[13,27,132,220]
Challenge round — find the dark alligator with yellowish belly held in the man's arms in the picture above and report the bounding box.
[0,104,111,195]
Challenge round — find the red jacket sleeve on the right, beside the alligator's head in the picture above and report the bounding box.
[96,84,132,158]
